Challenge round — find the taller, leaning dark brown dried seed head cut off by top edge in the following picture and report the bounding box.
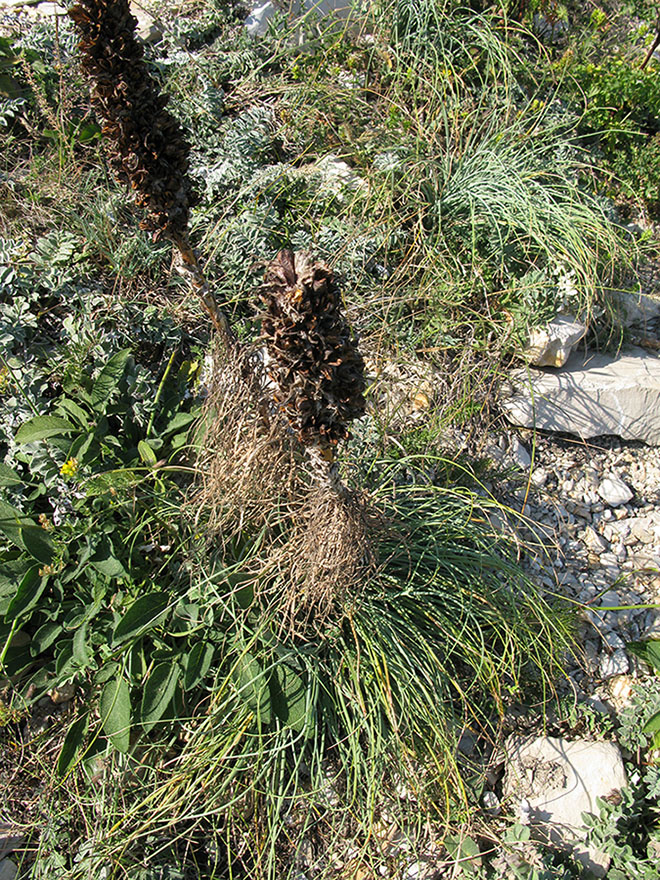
[69,0,195,241]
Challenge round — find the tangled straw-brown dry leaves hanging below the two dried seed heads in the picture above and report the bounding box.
[191,349,380,638]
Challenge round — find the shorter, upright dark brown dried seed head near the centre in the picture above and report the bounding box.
[261,251,365,447]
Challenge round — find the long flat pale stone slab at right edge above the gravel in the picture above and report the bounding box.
[503,348,660,446]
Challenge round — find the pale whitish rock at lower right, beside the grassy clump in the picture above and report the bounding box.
[503,736,627,877]
